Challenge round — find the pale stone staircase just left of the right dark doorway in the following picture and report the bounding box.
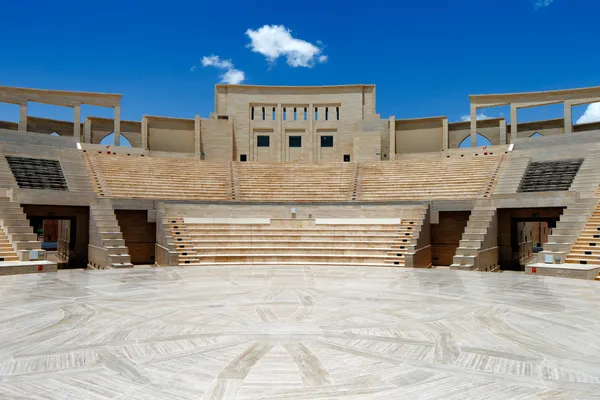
[450,200,497,270]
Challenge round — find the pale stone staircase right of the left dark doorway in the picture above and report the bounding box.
[89,199,133,269]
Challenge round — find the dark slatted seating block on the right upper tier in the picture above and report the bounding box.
[519,158,583,192]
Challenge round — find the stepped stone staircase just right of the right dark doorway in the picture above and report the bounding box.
[538,198,598,264]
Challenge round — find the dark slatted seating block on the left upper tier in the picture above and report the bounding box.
[6,156,68,190]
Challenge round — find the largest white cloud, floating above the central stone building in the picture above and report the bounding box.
[246,25,327,68]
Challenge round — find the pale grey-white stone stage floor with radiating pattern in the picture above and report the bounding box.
[0,267,600,400]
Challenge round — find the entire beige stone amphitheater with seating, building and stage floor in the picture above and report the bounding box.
[0,85,600,399]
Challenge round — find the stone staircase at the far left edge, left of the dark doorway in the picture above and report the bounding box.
[0,197,46,261]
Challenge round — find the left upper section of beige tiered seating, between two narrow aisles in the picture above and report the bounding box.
[86,153,231,200]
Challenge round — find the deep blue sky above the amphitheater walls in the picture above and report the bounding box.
[0,0,600,126]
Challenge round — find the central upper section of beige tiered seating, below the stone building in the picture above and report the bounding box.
[236,163,356,201]
